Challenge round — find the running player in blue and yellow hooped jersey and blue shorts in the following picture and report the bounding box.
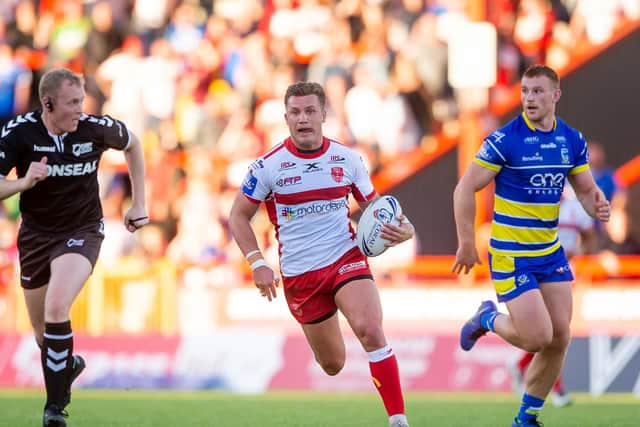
[453,65,610,426]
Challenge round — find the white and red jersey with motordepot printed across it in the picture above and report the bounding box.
[242,138,376,277]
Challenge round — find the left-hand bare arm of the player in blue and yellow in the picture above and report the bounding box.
[451,162,498,274]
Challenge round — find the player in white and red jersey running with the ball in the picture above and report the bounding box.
[230,82,414,427]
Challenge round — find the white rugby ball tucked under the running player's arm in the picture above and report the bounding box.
[356,196,402,257]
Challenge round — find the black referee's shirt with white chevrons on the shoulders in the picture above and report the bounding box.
[0,110,130,233]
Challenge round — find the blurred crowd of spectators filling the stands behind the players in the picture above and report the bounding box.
[0,0,640,294]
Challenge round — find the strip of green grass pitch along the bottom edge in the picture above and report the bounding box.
[0,390,640,427]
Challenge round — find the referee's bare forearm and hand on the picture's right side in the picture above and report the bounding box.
[124,133,149,233]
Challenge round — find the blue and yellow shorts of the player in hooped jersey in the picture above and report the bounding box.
[489,248,573,302]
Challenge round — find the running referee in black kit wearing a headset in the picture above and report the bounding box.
[0,68,149,427]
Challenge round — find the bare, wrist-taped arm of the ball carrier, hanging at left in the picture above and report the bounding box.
[229,191,279,301]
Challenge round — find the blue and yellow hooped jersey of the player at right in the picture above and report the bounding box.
[474,112,589,256]
